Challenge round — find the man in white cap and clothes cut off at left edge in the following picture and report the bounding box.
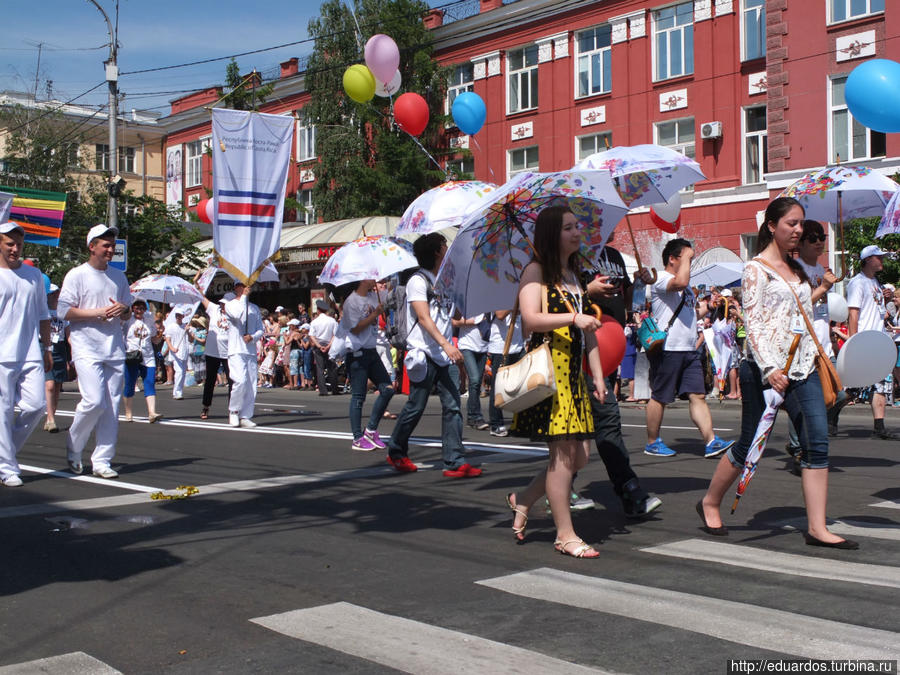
[0,222,53,487]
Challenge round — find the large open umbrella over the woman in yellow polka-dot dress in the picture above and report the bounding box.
[435,170,627,317]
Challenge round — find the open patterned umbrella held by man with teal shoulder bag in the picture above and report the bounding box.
[576,143,706,278]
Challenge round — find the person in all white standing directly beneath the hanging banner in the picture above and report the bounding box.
[225,281,264,429]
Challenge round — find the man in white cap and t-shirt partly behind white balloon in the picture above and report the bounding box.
[847,244,900,441]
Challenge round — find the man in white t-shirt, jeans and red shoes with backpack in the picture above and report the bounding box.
[387,232,481,478]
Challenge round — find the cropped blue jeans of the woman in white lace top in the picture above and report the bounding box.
[728,360,828,469]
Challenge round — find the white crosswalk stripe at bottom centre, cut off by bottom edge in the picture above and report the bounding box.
[251,602,603,675]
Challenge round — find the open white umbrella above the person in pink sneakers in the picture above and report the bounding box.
[319,236,419,286]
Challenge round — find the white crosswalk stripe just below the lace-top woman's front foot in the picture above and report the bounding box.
[640,539,900,588]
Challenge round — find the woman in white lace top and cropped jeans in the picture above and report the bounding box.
[697,197,858,549]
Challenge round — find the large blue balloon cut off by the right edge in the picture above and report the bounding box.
[844,59,900,133]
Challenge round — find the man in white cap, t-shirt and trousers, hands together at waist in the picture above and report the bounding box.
[57,224,132,478]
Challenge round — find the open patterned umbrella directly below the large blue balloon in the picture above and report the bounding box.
[779,166,900,281]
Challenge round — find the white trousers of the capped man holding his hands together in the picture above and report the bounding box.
[68,359,125,469]
